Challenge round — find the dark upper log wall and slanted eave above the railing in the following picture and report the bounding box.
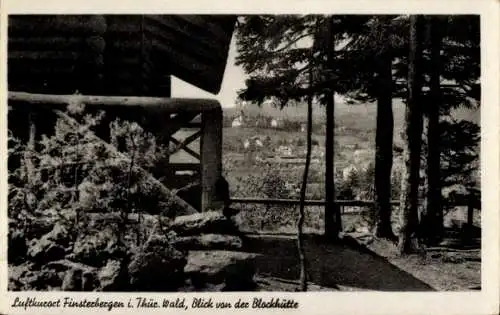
[8,15,236,97]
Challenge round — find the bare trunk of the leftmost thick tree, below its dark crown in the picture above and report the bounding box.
[375,53,396,241]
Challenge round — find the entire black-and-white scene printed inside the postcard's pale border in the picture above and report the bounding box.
[0,3,498,315]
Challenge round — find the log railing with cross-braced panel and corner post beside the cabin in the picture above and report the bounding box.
[8,91,222,212]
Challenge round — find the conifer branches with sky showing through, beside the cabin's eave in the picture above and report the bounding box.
[236,15,366,107]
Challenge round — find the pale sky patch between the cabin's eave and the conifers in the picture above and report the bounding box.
[171,36,246,107]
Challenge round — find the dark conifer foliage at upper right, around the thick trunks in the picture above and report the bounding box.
[336,15,480,107]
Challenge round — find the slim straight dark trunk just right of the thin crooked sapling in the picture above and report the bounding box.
[325,17,341,240]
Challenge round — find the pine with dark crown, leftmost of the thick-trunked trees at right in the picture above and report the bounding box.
[332,15,407,241]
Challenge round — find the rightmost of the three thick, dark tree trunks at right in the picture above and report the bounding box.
[423,18,443,243]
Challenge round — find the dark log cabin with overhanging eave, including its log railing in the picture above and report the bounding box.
[7,15,236,210]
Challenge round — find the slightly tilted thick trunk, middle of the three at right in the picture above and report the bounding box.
[398,15,422,255]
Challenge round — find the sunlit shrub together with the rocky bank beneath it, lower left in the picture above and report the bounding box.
[8,105,193,291]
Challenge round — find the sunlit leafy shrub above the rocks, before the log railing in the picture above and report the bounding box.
[9,104,180,248]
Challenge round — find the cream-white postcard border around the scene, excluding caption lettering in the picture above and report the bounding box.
[0,0,500,314]
